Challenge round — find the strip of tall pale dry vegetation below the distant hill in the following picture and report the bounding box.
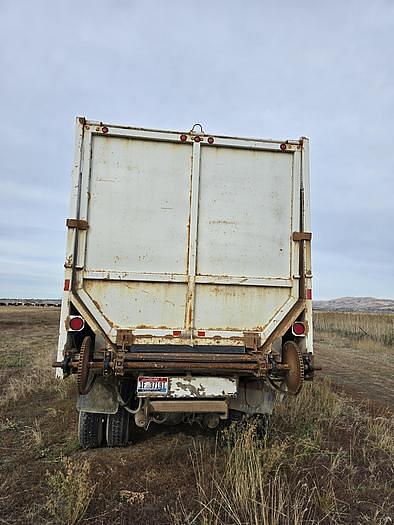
[313,312,394,346]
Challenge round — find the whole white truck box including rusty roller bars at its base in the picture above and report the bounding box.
[57,118,313,446]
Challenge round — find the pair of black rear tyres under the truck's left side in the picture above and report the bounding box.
[78,407,130,448]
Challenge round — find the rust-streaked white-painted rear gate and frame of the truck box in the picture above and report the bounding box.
[58,118,311,359]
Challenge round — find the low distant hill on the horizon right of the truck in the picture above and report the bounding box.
[313,297,394,313]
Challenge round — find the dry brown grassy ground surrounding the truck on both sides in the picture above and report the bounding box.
[0,307,394,525]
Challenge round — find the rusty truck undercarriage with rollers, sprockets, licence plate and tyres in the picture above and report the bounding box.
[53,296,316,447]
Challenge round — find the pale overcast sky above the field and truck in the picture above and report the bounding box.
[0,0,394,299]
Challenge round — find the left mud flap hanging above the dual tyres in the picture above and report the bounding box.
[77,377,119,414]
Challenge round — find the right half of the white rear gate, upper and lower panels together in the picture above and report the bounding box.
[189,146,295,331]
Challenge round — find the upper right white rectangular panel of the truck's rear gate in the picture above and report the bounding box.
[197,146,293,279]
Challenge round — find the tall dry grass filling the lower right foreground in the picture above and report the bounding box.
[172,381,394,525]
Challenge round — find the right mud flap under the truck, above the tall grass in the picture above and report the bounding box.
[229,380,276,414]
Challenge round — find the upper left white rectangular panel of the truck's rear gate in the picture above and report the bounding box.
[85,136,192,274]
